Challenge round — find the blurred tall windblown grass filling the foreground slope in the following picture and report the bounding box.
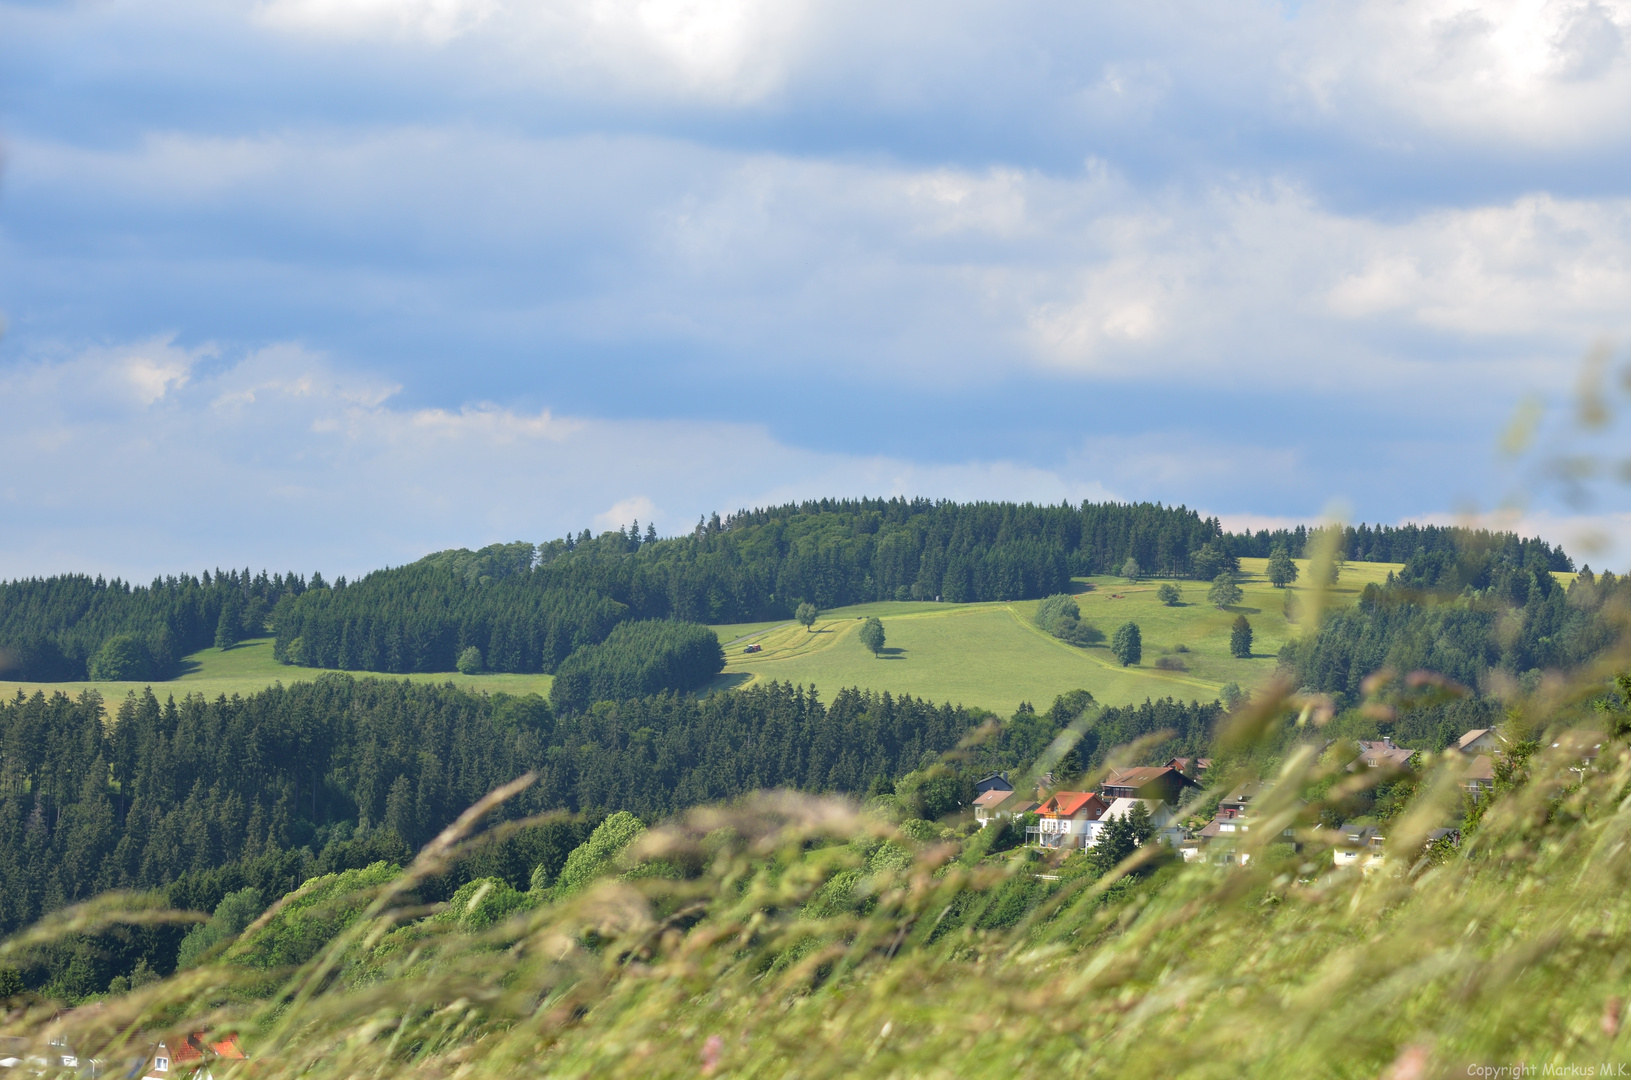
[5,659,1631,1080]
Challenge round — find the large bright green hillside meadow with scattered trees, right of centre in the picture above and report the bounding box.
[718,560,1399,715]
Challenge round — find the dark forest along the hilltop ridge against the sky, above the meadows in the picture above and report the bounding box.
[0,498,1572,682]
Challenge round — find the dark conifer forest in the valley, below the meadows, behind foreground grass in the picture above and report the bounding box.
[0,675,983,932]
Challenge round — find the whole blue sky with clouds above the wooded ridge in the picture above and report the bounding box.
[0,0,1631,581]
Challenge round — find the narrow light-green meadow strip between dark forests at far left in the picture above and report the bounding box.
[0,638,551,706]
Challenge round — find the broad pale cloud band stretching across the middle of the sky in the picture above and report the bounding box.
[11,127,1631,395]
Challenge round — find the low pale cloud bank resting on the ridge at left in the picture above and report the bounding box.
[0,343,1109,578]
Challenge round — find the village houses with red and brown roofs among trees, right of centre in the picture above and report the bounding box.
[974,728,1526,871]
